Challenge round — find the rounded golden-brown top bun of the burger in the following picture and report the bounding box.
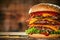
[29,3,60,14]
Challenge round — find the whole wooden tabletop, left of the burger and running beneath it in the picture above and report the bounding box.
[0,32,60,40]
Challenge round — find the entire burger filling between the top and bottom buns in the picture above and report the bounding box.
[28,11,60,35]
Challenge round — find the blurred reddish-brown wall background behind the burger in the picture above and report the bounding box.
[0,0,60,32]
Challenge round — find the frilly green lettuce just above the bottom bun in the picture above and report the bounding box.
[25,27,60,34]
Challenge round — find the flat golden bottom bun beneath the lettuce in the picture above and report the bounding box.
[29,34,60,38]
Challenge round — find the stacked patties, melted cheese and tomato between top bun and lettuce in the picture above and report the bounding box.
[29,13,60,33]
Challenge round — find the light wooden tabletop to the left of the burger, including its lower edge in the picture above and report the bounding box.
[0,32,27,38]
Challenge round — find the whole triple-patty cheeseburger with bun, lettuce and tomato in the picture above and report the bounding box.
[26,3,60,38]
